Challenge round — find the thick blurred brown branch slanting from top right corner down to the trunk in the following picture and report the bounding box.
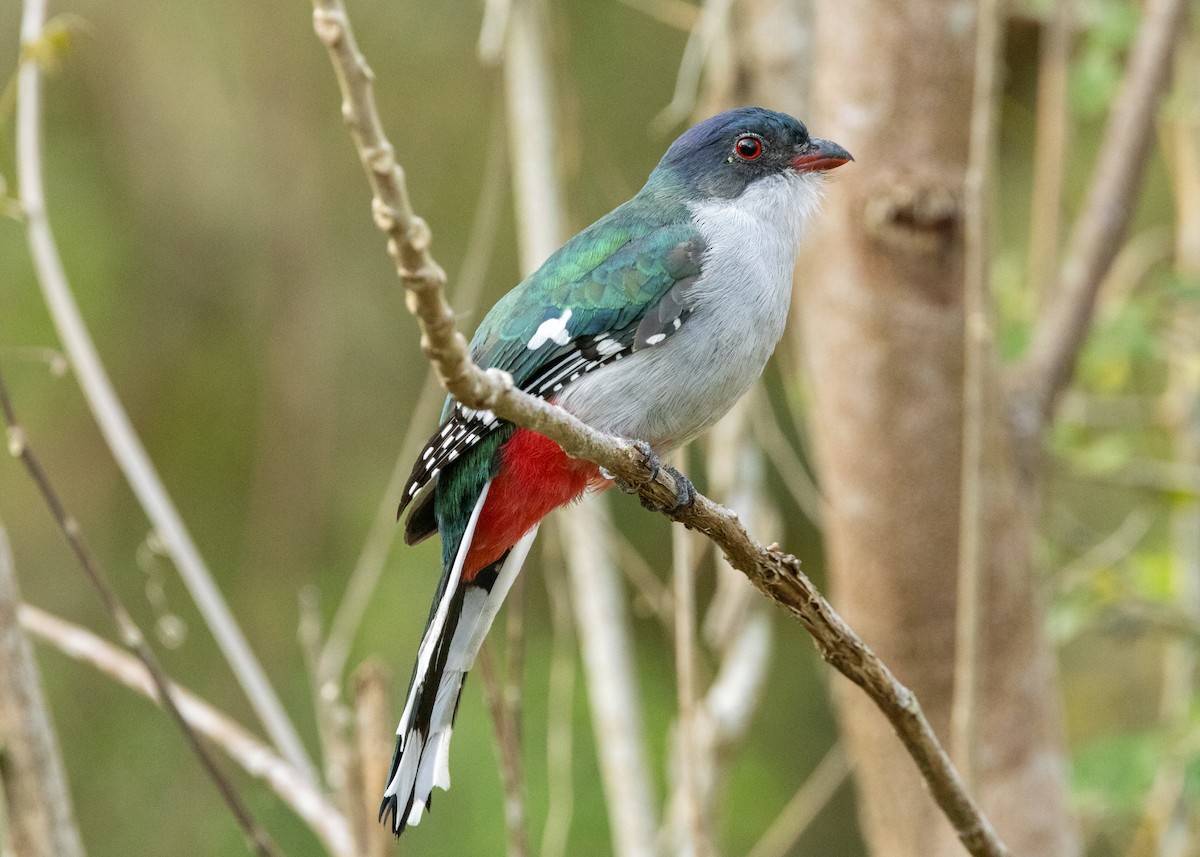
[1013,0,1186,434]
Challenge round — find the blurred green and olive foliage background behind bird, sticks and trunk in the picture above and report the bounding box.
[0,0,1200,857]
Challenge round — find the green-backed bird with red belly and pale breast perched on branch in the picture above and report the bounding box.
[379,107,853,837]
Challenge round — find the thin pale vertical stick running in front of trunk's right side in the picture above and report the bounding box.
[950,0,1001,789]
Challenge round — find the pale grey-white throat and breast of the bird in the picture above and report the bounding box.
[558,173,821,453]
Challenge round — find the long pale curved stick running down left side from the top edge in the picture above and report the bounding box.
[17,0,316,781]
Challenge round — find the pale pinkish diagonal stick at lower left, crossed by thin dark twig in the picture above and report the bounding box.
[20,604,359,857]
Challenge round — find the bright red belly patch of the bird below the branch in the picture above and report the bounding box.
[463,429,604,580]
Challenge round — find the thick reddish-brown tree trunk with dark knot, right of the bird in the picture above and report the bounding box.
[799,0,1079,857]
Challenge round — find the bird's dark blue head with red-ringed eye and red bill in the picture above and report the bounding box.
[649,107,854,199]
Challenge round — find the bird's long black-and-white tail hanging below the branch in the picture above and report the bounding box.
[379,483,538,837]
